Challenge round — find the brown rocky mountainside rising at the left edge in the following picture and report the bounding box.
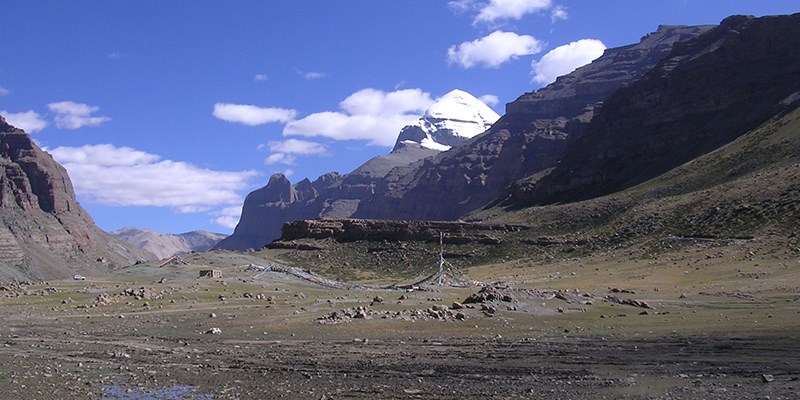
[0,117,153,280]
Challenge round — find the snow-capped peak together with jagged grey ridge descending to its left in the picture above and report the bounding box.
[215,90,498,250]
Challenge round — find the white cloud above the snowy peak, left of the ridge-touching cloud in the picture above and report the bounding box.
[447,30,542,68]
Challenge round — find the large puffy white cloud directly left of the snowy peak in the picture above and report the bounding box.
[283,88,433,146]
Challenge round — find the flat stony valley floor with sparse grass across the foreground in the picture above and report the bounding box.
[0,234,800,400]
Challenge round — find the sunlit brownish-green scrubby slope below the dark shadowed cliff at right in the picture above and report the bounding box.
[473,96,800,244]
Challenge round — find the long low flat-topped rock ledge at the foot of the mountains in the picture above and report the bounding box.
[271,219,528,248]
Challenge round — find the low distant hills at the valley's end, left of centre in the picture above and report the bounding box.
[111,228,227,258]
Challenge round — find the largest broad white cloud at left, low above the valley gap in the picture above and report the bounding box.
[47,144,257,217]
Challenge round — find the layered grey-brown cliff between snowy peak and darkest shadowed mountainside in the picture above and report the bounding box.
[353,26,712,220]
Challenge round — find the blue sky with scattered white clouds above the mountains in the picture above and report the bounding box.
[0,0,800,233]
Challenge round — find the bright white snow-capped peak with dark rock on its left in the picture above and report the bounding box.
[394,89,500,151]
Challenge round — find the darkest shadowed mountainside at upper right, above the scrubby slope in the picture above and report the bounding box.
[504,14,800,206]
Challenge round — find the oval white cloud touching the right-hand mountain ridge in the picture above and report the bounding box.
[531,39,606,84]
